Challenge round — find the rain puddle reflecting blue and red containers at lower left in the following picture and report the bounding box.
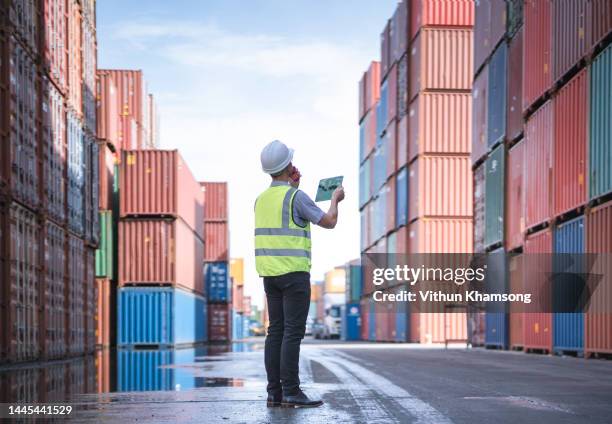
[0,341,262,403]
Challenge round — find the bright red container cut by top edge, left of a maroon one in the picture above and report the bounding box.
[523,0,552,111]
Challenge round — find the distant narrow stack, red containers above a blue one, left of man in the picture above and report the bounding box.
[200,182,232,342]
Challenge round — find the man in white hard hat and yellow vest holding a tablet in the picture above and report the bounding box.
[255,140,344,408]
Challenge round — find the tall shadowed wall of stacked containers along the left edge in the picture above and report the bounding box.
[0,0,99,362]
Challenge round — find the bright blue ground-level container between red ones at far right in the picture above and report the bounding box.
[553,216,584,352]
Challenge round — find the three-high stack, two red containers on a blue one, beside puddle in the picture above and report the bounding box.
[117,150,207,348]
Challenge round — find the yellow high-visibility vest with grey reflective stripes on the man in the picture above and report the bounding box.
[255,185,311,277]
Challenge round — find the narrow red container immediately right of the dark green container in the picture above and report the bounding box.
[505,140,525,250]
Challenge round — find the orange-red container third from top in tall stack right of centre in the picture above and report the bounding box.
[408,93,472,162]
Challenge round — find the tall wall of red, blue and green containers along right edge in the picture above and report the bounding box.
[471,0,612,356]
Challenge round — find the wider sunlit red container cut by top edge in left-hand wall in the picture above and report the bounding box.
[42,0,68,93]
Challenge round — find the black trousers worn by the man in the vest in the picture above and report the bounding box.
[264,272,310,395]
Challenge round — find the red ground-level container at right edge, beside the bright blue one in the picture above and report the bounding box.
[584,202,612,354]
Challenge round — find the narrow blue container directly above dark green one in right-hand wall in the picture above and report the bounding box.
[487,43,508,147]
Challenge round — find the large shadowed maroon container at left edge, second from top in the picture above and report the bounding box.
[0,34,40,208]
